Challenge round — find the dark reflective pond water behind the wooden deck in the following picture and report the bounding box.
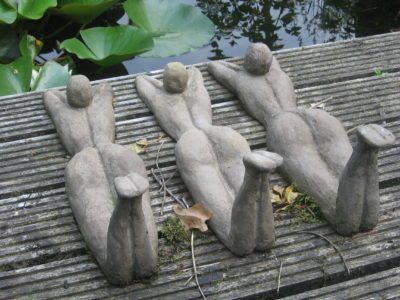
[120,0,400,74]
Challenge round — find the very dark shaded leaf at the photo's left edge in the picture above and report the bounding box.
[0,26,21,63]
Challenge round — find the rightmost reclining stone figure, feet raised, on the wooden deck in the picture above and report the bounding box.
[208,43,395,236]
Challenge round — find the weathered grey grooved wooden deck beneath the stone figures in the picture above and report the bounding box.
[0,33,400,299]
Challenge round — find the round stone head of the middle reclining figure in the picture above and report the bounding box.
[164,62,189,94]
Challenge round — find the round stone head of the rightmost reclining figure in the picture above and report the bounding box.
[243,43,273,75]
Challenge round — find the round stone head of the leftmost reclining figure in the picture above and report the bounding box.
[67,75,93,108]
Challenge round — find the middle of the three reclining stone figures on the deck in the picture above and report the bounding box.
[136,63,282,255]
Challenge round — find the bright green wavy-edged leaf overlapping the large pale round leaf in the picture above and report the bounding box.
[60,25,153,67]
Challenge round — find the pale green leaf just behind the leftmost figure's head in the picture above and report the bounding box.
[31,60,71,91]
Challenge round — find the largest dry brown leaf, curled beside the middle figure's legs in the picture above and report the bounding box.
[173,203,212,231]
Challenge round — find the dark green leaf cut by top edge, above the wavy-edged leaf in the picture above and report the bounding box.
[55,0,117,24]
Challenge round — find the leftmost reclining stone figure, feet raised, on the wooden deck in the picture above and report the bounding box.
[44,75,158,285]
